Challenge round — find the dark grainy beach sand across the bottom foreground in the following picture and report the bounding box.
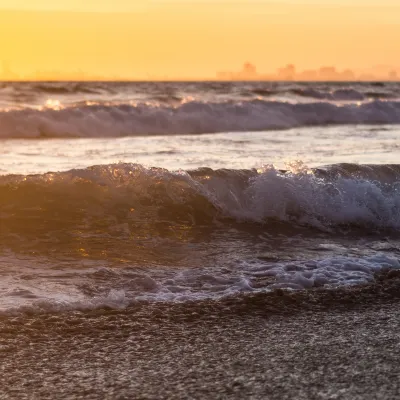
[0,273,400,399]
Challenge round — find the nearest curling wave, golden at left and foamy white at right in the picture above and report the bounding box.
[0,163,400,240]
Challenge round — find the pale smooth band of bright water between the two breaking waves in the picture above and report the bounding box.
[0,125,400,175]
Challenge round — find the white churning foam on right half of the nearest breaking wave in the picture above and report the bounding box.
[184,164,400,230]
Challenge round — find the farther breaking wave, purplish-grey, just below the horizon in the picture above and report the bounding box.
[0,100,400,138]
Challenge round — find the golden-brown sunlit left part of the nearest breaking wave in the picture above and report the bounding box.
[0,162,215,267]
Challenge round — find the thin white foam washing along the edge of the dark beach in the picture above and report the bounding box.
[0,253,400,314]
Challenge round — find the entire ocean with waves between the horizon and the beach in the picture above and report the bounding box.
[0,82,400,316]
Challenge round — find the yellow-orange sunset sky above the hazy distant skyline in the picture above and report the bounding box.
[0,0,400,79]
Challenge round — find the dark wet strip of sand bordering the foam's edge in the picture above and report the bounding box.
[0,269,400,322]
